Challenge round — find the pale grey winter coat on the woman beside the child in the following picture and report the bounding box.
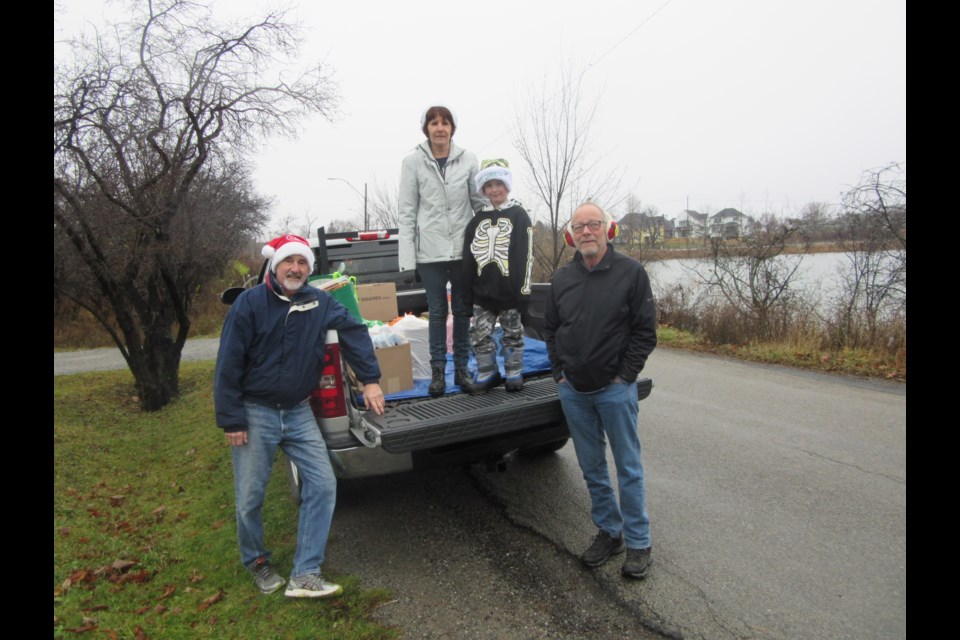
[400,140,486,271]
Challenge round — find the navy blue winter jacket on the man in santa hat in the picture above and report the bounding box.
[213,278,380,431]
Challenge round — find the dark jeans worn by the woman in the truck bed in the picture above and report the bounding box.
[417,260,470,369]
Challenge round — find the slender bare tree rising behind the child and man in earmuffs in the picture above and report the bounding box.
[513,68,622,276]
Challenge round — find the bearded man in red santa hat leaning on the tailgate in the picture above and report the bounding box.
[214,234,384,598]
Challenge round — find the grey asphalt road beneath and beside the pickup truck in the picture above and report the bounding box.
[54,340,906,639]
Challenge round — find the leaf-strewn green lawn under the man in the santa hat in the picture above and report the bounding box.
[53,362,398,640]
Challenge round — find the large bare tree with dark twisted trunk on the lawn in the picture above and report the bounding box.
[53,0,336,410]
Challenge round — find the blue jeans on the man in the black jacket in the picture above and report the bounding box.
[557,380,650,549]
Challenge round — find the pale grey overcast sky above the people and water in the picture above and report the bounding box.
[54,0,907,231]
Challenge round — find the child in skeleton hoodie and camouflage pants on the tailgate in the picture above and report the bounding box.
[463,160,533,394]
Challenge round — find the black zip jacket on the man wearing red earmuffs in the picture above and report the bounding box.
[544,245,657,392]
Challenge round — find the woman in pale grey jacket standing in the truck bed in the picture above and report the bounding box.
[400,106,485,397]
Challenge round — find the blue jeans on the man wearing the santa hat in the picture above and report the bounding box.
[230,400,337,578]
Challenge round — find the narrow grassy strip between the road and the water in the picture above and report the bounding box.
[657,325,907,382]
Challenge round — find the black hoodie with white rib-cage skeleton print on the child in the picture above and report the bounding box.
[463,198,533,312]
